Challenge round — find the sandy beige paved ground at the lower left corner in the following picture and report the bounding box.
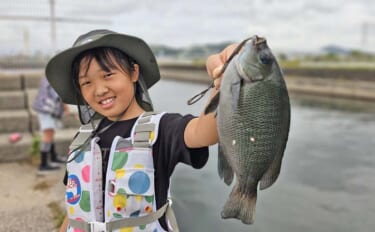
[0,162,64,232]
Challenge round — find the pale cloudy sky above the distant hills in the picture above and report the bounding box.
[0,0,375,54]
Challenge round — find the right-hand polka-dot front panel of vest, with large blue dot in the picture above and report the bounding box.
[105,139,156,232]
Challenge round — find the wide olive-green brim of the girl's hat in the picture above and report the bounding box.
[46,33,160,105]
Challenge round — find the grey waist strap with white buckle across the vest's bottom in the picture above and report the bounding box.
[69,199,179,232]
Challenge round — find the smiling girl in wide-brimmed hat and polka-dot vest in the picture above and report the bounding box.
[46,30,226,232]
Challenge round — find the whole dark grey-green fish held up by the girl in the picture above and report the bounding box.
[204,35,291,224]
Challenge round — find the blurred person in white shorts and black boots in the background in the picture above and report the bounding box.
[33,77,68,175]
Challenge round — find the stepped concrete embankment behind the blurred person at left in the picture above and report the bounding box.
[0,72,79,162]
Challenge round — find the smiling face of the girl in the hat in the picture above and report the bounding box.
[78,57,143,121]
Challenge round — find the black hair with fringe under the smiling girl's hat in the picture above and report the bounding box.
[72,47,142,109]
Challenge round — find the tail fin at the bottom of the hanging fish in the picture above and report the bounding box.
[221,183,257,224]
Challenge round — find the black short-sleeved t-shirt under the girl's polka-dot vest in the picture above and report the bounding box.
[64,113,208,229]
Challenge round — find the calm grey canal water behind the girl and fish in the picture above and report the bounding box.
[150,80,375,232]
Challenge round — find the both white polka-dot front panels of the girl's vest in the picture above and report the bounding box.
[66,117,157,232]
